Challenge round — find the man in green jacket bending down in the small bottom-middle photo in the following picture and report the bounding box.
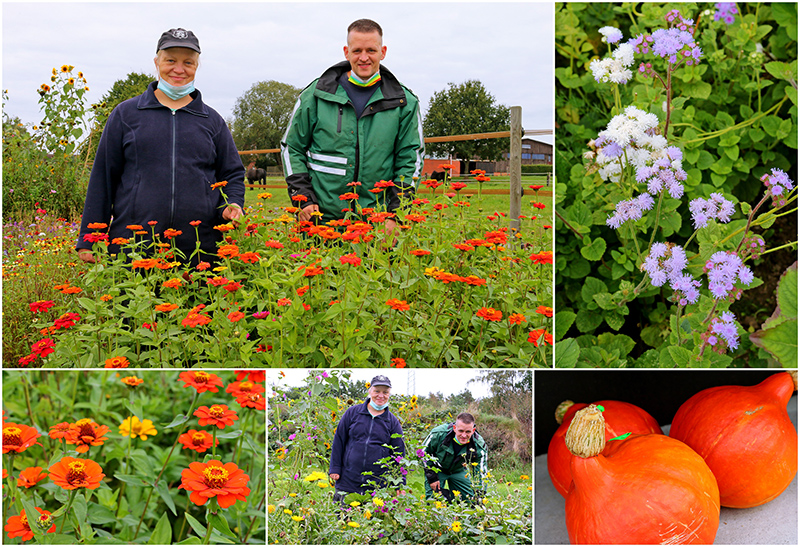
[423,412,488,501]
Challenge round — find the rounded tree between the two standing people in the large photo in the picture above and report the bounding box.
[231,80,302,167]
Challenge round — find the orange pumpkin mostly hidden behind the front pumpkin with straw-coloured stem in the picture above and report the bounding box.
[547,401,661,497]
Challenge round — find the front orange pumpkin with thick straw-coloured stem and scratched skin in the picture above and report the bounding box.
[565,405,719,545]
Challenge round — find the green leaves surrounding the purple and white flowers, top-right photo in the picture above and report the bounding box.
[556,2,797,367]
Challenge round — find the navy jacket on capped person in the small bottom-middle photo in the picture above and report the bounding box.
[329,398,406,494]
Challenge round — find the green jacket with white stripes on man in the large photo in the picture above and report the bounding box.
[281,61,425,222]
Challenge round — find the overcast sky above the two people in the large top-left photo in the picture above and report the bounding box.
[2,2,554,143]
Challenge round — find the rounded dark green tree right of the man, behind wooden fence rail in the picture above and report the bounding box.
[422,80,509,160]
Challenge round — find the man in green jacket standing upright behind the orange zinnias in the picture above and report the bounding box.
[281,19,425,238]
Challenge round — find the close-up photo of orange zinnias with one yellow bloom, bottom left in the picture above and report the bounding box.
[3,371,266,545]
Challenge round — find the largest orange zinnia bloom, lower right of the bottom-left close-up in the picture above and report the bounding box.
[180,460,250,509]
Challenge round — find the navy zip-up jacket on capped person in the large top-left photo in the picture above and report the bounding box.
[76,82,244,264]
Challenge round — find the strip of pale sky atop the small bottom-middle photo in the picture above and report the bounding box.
[266,368,504,399]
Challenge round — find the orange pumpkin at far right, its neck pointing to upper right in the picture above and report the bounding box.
[669,372,797,508]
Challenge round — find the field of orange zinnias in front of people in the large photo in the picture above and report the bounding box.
[3,181,553,368]
